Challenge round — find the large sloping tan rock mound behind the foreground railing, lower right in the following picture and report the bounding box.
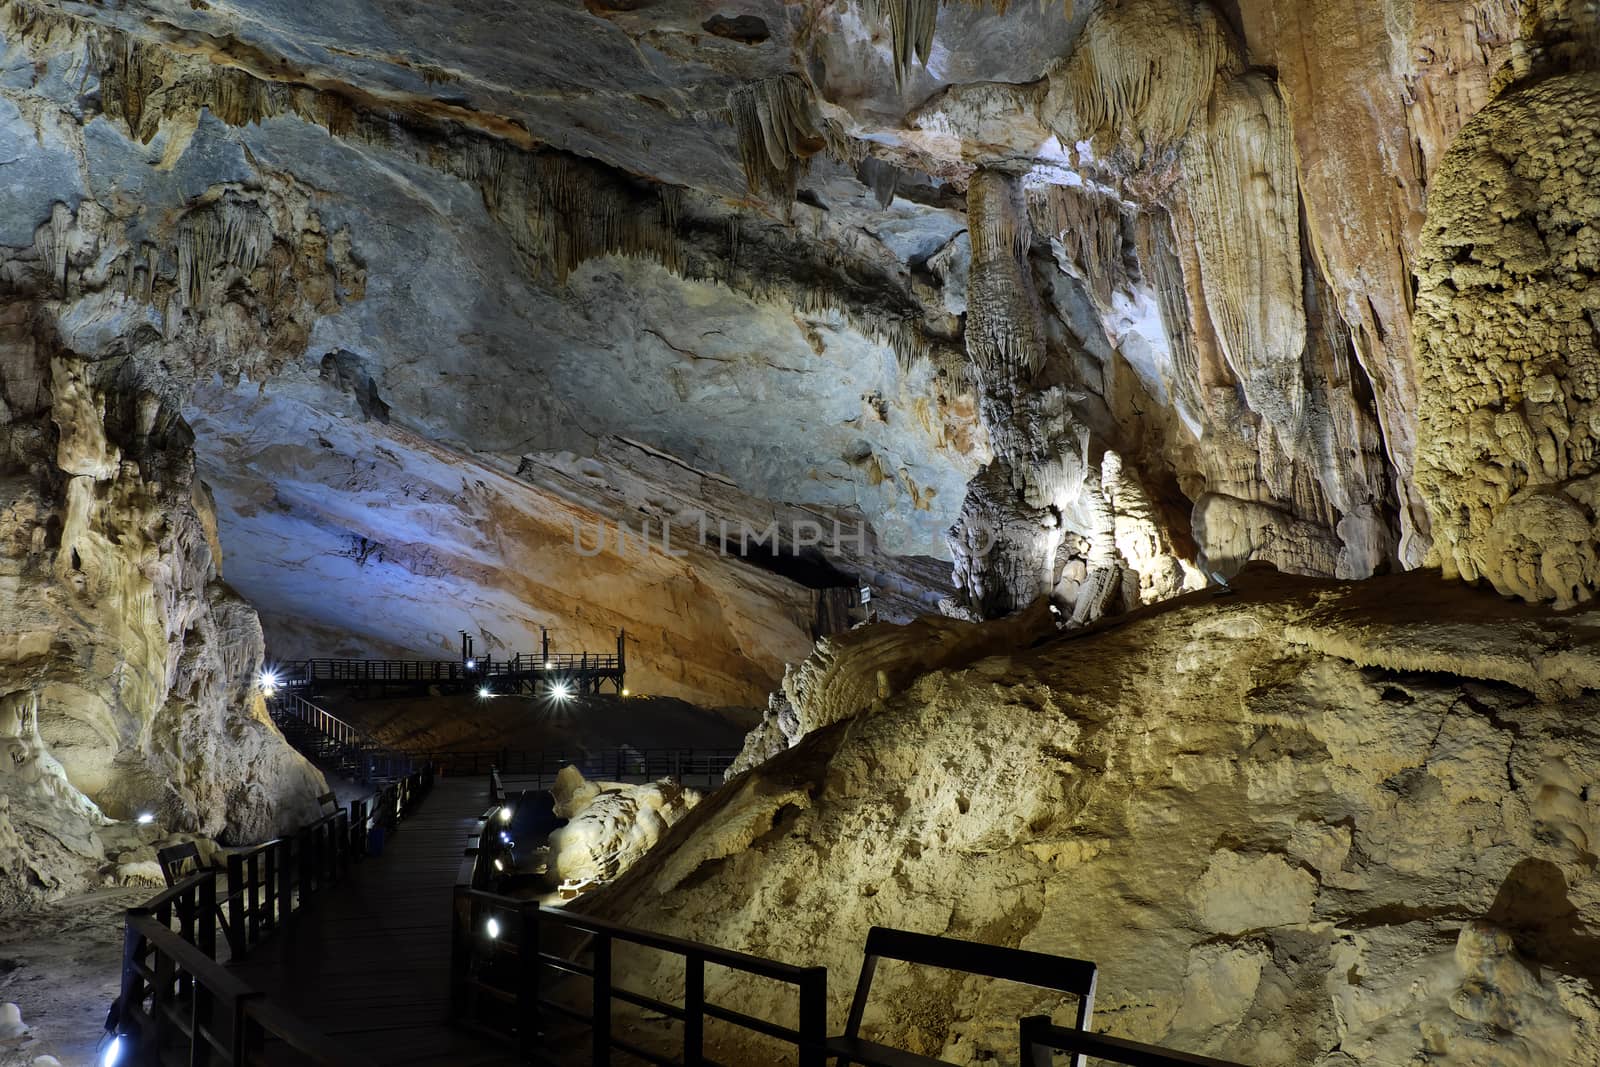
[581,569,1600,1067]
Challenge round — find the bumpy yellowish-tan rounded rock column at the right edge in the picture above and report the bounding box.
[1416,58,1600,606]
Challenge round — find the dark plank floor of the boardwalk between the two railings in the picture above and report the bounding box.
[230,777,522,1067]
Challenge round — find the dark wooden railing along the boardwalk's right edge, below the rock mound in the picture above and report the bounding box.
[450,806,827,1067]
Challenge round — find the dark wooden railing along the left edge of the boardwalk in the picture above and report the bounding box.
[110,769,432,1067]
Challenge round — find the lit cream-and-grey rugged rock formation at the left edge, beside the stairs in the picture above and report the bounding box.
[0,331,323,889]
